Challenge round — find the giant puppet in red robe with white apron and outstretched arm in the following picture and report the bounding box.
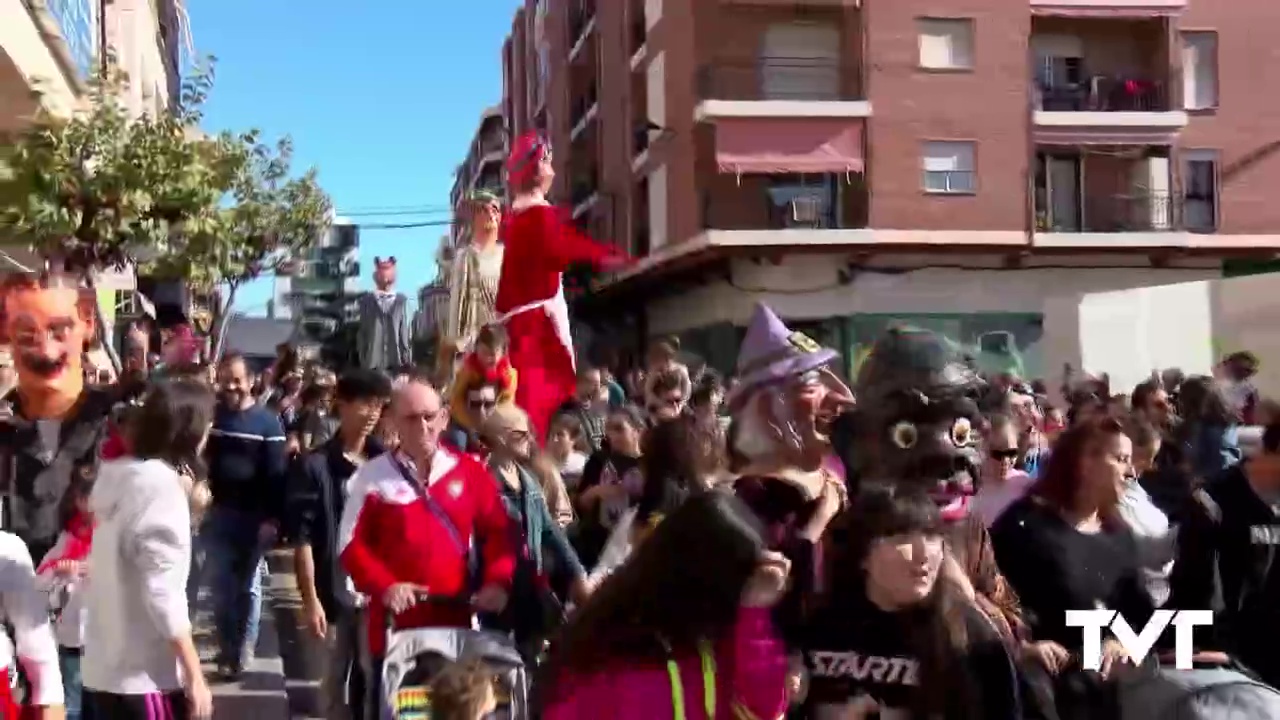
[494,133,626,441]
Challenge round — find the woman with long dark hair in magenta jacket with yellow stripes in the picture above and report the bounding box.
[536,493,788,720]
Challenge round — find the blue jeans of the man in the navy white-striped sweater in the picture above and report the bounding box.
[200,506,264,665]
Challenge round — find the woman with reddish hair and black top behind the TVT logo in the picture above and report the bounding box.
[991,415,1153,719]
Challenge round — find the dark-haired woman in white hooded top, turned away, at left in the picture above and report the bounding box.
[82,380,214,720]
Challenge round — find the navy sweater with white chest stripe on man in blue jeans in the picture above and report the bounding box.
[205,405,285,520]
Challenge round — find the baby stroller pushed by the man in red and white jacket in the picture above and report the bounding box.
[378,593,531,720]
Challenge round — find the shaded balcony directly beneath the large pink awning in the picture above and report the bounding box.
[703,174,868,231]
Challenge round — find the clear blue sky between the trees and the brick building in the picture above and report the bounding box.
[187,0,520,315]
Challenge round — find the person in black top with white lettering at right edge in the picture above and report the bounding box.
[1166,424,1280,687]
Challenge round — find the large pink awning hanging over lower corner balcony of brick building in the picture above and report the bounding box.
[716,118,863,174]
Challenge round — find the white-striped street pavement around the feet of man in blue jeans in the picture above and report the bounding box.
[195,545,321,720]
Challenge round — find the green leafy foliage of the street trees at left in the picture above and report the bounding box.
[0,59,330,288]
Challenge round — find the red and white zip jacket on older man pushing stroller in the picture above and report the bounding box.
[338,446,516,656]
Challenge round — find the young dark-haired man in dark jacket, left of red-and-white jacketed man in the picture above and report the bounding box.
[288,370,392,720]
